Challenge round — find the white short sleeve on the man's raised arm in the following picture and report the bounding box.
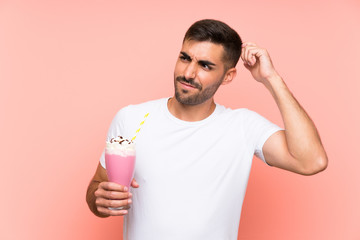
[245,110,284,163]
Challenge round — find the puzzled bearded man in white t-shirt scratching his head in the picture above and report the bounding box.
[87,20,327,240]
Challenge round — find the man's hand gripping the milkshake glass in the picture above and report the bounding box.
[94,182,132,216]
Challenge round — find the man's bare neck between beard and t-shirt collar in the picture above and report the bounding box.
[167,97,216,122]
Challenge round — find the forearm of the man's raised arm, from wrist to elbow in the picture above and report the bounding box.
[266,75,327,167]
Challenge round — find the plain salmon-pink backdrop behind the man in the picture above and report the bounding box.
[0,0,360,240]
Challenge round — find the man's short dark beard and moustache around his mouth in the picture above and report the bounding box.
[174,76,223,105]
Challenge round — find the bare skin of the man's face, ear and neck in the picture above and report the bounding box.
[168,40,236,122]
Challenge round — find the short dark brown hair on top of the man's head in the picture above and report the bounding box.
[183,19,242,68]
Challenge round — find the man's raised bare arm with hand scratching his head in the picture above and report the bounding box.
[241,43,328,175]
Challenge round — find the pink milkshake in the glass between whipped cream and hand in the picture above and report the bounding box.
[105,151,135,189]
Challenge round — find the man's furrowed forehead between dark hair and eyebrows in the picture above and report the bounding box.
[181,40,224,63]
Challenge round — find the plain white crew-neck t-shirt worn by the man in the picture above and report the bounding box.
[100,98,281,240]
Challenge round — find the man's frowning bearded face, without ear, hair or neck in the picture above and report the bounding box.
[174,40,233,105]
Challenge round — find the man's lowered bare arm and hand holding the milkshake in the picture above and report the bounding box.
[86,163,139,217]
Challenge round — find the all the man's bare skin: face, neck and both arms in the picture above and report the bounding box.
[86,41,328,217]
